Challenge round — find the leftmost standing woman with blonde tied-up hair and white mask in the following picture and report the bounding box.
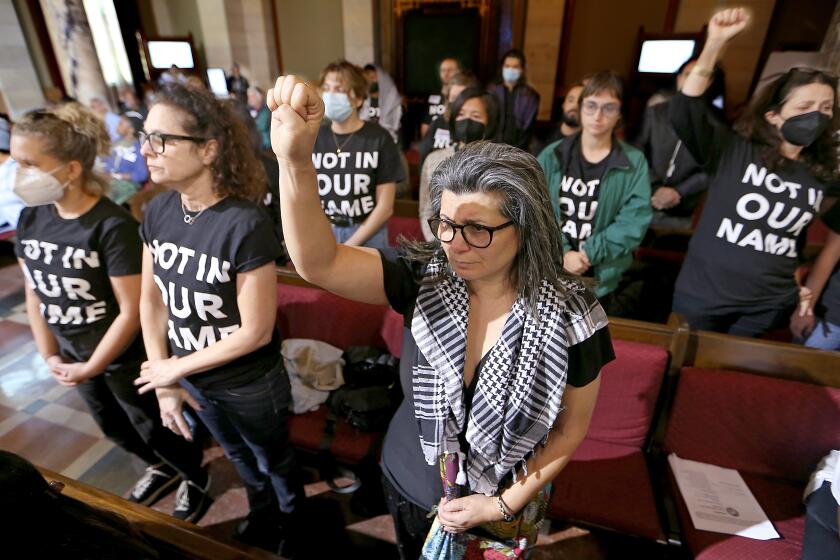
[11,103,207,520]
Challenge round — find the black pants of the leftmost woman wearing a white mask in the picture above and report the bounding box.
[77,363,204,480]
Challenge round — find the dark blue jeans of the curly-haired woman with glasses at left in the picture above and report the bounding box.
[181,362,304,521]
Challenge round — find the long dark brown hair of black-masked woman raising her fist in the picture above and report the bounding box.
[736,68,840,182]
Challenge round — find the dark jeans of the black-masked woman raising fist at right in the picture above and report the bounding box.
[673,292,794,337]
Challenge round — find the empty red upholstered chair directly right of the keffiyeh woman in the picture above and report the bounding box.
[549,340,669,542]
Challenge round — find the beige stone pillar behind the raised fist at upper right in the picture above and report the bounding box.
[674,0,776,108]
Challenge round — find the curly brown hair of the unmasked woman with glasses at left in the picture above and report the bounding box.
[155,83,266,203]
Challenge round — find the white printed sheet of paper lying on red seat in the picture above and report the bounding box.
[668,453,779,541]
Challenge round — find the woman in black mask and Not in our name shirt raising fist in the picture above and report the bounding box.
[670,8,840,336]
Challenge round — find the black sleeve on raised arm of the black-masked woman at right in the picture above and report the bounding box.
[669,93,735,175]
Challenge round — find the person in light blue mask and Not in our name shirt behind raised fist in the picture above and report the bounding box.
[312,60,404,248]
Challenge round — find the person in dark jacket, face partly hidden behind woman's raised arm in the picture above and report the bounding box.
[636,59,716,229]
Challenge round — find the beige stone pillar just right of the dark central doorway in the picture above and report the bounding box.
[524,0,566,120]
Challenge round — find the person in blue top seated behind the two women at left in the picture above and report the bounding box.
[101,111,149,204]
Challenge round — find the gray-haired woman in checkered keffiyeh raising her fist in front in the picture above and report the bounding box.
[267,76,614,560]
